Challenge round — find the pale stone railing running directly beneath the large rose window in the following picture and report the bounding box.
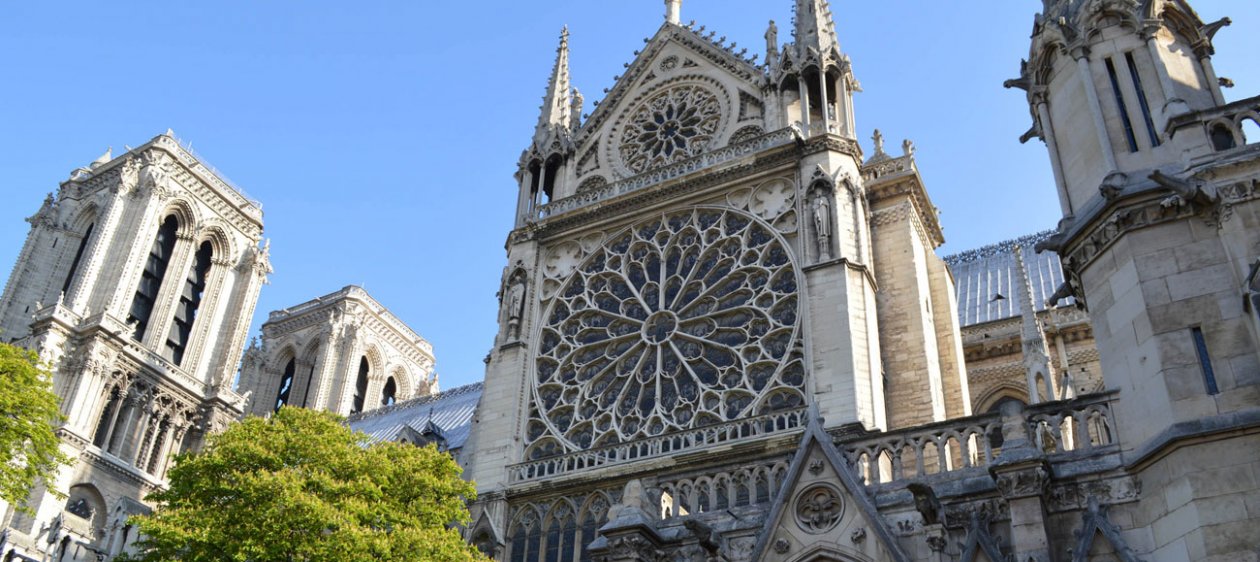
[508,408,809,483]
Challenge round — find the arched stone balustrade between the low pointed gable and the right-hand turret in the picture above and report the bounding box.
[842,393,1118,485]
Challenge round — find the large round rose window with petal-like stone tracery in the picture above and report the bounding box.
[528,209,805,459]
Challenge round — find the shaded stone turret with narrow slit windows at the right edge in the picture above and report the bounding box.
[1007,0,1260,559]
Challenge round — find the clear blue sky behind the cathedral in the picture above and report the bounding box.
[0,0,1260,388]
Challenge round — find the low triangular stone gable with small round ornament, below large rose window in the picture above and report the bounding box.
[751,412,911,562]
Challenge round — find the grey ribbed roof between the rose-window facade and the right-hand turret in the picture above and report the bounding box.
[945,231,1075,328]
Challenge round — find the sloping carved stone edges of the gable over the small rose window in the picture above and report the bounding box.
[576,23,766,144]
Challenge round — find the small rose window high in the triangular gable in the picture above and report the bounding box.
[621,86,722,173]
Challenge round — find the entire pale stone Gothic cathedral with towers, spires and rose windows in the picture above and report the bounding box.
[0,0,1260,562]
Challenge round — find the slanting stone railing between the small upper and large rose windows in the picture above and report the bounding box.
[533,127,800,221]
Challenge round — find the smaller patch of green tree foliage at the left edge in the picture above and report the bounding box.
[0,343,69,512]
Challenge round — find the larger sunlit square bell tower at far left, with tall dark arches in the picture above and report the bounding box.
[0,131,271,558]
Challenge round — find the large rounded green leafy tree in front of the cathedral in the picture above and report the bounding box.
[121,408,485,562]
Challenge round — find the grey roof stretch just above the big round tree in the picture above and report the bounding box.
[347,383,481,450]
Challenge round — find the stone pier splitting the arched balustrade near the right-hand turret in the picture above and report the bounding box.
[989,403,1052,562]
